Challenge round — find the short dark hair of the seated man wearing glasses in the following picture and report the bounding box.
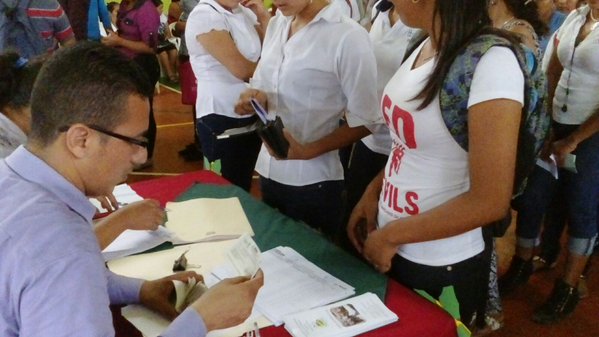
[29,42,154,146]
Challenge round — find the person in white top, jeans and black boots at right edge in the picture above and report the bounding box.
[533,0,599,324]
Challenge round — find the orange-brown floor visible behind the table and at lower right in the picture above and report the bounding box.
[136,84,599,337]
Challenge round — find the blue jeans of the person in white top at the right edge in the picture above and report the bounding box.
[547,123,599,254]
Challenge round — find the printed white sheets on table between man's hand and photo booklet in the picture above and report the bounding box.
[212,247,355,326]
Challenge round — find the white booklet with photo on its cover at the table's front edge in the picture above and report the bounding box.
[285,293,398,337]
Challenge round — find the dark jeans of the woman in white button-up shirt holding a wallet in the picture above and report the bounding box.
[260,177,345,240]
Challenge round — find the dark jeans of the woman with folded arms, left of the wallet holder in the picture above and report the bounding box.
[196,114,262,191]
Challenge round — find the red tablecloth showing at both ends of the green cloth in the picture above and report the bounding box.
[124,171,456,337]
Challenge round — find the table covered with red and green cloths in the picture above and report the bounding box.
[124,171,456,337]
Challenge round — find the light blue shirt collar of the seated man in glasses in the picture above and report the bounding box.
[6,145,96,223]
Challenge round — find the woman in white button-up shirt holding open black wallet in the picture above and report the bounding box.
[236,0,381,237]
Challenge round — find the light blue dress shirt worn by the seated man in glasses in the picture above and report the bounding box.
[0,146,206,337]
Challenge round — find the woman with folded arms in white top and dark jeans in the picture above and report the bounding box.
[185,0,270,191]
